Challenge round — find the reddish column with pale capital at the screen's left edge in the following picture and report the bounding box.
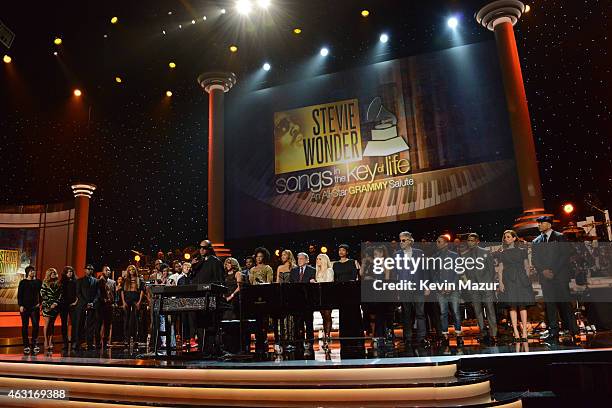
[198,72,236,256]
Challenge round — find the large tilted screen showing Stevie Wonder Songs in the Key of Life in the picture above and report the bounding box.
[231,42,520,239]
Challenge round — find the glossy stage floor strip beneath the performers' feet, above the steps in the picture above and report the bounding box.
[0,338,612,368]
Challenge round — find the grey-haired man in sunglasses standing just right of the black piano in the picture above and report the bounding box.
[394,231,429,345]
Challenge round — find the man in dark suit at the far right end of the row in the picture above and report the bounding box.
[531,216,578,343]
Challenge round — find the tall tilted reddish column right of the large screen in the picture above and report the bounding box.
[475,0,544,232]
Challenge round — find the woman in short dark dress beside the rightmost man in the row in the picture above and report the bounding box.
[497,230,535,342]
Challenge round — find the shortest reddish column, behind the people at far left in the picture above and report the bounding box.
[71,183,96,277]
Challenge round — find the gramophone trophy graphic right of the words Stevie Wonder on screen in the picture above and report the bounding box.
[363,96,410,157]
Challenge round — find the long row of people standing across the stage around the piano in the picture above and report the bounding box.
[18,217,600,354]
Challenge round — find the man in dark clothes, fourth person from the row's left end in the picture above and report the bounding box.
[72,265,100,350]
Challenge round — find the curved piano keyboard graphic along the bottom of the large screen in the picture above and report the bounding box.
[241,160,514,220]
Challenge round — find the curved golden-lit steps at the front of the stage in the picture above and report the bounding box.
[0,360,521,407]
